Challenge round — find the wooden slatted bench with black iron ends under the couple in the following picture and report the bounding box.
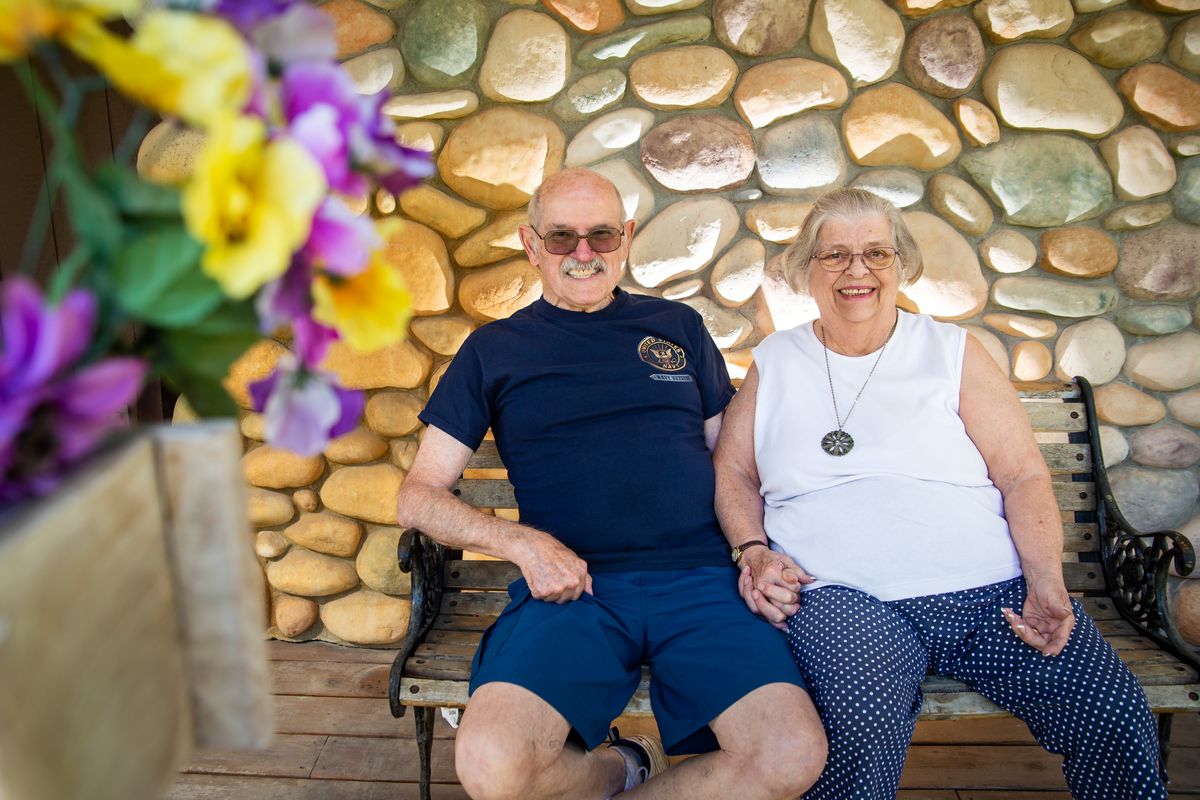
[390,379,1200,800]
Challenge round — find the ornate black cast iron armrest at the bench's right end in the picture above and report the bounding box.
[1075,378,1200,668]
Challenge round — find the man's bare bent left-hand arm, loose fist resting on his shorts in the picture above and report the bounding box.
[396,426,592,603]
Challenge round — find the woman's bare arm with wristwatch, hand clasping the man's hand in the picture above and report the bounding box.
[713,366,814,628]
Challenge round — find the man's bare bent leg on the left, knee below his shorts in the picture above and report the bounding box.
[455,682,625,800]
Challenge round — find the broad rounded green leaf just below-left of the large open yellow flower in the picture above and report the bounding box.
[112,224,223,327]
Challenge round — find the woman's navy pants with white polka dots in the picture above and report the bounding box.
[787,578,1166,800]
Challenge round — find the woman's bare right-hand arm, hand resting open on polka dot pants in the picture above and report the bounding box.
[959,335,1075,655]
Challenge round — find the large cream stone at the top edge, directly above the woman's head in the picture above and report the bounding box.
[809,0,904,86]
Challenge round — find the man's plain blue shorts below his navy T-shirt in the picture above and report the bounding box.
[470,566,804,756]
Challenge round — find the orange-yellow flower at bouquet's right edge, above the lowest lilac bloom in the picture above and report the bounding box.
[312,231,413,353]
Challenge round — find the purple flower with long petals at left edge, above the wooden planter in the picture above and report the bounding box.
[0,276,146,503]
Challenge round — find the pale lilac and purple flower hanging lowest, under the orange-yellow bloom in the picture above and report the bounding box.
[250,359,365,456]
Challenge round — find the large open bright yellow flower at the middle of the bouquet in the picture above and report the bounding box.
[184,116,325,303]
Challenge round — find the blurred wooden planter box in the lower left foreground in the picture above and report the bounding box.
[0,421,272,800]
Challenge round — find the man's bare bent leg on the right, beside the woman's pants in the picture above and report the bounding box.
[620,684,826,800]
